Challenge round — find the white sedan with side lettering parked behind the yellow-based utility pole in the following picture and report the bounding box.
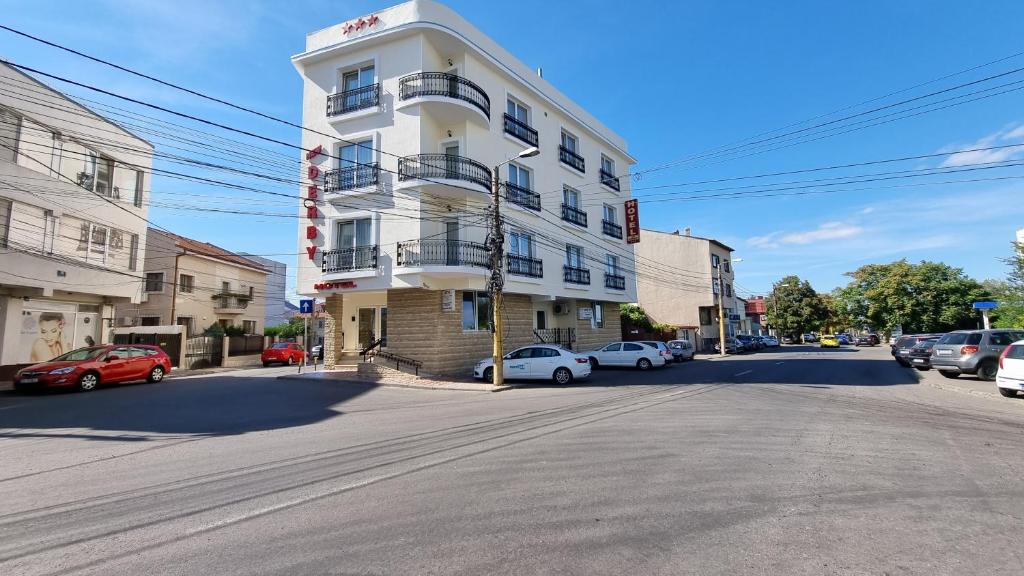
[473,344,590,384]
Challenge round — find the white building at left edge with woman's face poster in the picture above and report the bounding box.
[0,65,153,366]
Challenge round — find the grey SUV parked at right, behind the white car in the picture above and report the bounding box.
[932,330,1024,381]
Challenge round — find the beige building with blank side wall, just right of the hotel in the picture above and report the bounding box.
[636,229,745,352]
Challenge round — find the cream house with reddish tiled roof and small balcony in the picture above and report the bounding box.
[117,228,268,334]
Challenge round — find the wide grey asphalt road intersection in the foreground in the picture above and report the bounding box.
[0,346,1024,576]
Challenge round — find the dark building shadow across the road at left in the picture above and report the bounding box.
[0,375,376,442]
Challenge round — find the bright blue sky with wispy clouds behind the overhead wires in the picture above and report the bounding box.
[0,0,1024,301]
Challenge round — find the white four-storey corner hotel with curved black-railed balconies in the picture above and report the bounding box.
[292,0,636,373]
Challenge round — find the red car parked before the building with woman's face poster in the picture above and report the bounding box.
[14,344,171,390]
